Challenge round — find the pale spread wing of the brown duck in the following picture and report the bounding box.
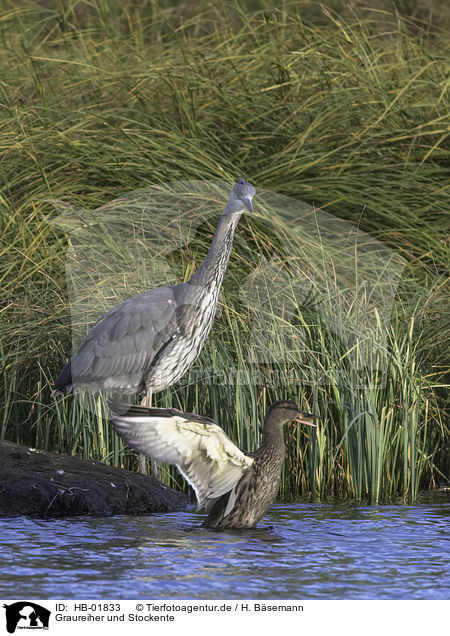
[110,402,254,509]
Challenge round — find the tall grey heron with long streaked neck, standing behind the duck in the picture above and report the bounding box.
[52,179,255,396]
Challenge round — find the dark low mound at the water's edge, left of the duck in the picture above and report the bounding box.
[0,440,189,517]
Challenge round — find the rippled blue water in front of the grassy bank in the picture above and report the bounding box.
[0,501,450,600]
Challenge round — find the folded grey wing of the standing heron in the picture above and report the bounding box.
[71,285,185,388]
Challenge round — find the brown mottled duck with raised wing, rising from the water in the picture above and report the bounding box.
[111,401,315,528]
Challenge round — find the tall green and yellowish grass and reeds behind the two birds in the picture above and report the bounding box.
[0,1,450,501]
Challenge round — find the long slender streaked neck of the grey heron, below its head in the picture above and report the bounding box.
[189,212,242,291]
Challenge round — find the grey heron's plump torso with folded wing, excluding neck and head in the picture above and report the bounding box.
[55,283,215,394]
